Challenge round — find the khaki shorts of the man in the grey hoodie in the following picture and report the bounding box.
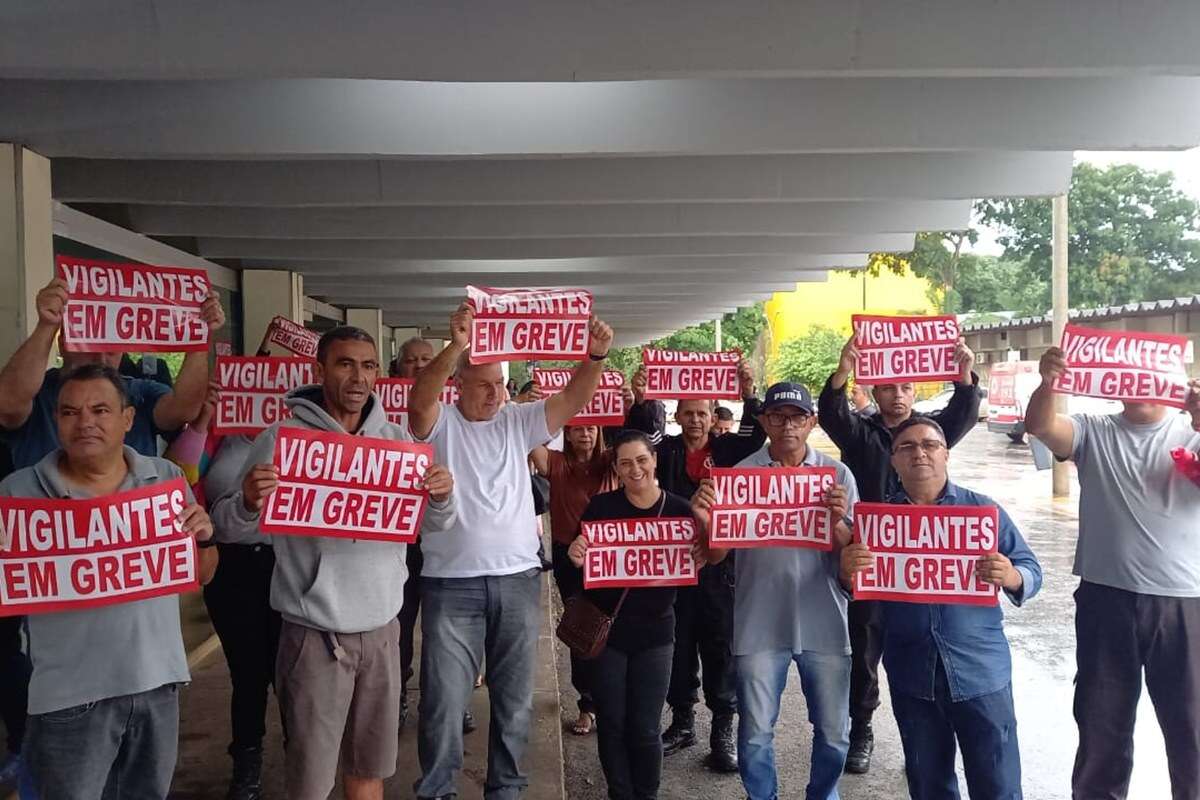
[275,619,400,800]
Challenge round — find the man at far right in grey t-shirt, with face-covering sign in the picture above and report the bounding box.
[1025,340,1200,798]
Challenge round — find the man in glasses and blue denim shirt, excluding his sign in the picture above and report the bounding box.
[841,416,1042,800]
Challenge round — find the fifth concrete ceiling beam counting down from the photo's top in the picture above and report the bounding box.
[197,234,914,263]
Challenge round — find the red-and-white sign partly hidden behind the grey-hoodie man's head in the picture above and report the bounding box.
[214,356,317,437]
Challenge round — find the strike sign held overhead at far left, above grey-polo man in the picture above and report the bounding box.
[55,255,209,353]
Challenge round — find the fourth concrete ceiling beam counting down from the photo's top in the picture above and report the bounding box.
[130,200,971,240]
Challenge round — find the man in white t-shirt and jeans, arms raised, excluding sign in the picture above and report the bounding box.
[408,305,612,800]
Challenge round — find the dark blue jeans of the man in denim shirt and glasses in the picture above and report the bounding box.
[892,661,1021,800]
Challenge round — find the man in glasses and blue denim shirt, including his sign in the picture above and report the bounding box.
[841,417,1036,800]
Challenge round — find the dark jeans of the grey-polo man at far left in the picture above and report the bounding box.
[24,684,179,800]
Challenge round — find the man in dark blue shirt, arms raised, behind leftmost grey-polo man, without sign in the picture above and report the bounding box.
[0,278,224,469]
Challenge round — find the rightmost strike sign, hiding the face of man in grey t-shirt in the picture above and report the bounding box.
[1054,325,1188,408]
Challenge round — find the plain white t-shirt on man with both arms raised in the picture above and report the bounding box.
[421,401,551,578]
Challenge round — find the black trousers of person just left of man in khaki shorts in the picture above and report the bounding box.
[204,545,280,753]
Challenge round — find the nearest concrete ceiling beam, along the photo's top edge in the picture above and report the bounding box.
[0,0,1200,82]
